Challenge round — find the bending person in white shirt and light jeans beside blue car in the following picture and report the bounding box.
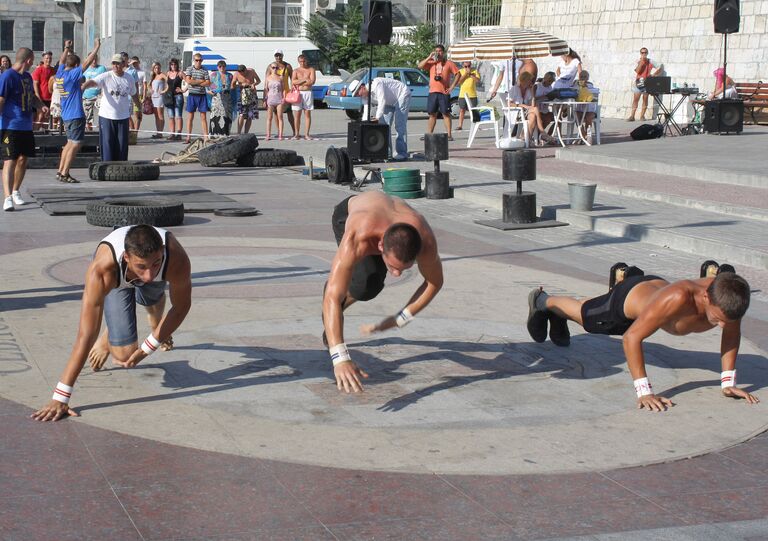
[349,77,411,160]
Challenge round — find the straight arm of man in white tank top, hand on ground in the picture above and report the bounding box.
[32,251,114,421]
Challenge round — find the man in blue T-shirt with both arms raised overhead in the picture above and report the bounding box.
[54,38,101,183]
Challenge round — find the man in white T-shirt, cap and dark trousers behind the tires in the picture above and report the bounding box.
[82,54,139,162]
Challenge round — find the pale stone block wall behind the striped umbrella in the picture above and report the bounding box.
[501,0,768,117]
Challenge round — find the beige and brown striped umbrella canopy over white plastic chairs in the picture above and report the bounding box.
[448,28,568,62]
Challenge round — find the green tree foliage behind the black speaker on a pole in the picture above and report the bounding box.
[304,0,435,72]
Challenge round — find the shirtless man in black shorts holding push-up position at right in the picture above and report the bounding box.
[528,272,759,411]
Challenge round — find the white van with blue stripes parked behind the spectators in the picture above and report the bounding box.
[181,37,341,105]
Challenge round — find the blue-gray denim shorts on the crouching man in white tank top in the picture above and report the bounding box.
[104,281,166,346]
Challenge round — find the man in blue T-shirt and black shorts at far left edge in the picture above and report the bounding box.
[0,47,48,211]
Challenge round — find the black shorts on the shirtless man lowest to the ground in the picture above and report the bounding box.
[581,275,663,336]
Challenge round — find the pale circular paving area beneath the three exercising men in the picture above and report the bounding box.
[6,237,768,474]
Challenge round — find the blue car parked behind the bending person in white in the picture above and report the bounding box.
[323,68,459,120]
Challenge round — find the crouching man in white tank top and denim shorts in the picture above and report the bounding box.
[32,225,192,421]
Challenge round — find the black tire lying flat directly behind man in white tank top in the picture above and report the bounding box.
[85,197,184,227]
